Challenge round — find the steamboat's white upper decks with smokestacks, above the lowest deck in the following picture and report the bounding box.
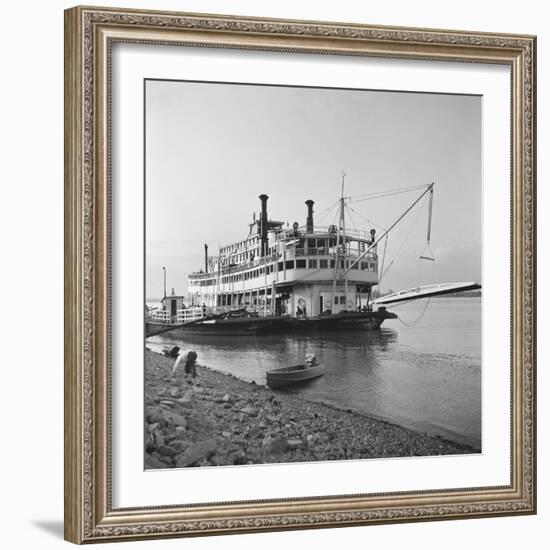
[188,195,378,300]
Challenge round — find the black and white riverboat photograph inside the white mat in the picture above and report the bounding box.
[143,79,483,470]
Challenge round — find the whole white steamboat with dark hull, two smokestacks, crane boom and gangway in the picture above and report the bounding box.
[146,176,480,336]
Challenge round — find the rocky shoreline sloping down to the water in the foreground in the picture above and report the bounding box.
[145,350,479,469]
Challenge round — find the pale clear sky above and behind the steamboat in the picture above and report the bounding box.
[145,80,482,299]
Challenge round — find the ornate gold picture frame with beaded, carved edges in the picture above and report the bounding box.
[65,7,536,543]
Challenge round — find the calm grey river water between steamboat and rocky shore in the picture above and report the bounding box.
[147,298,481,449]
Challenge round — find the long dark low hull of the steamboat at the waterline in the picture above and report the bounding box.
[146,310,397,336]
